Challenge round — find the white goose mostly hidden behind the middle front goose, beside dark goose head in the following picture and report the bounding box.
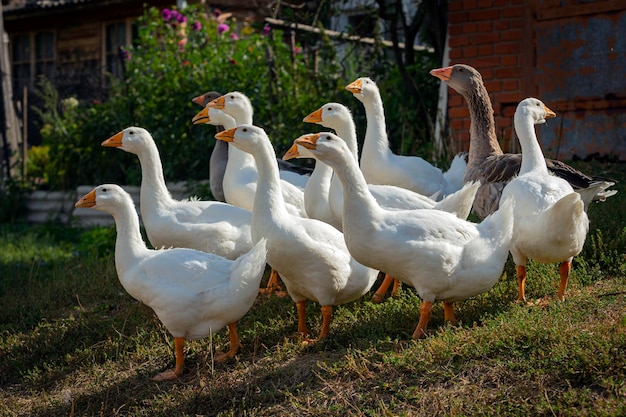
[199,92,309,216]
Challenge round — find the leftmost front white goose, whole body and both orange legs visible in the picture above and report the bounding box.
[75,184,266,380]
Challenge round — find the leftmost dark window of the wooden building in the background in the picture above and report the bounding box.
[11,32,56,92]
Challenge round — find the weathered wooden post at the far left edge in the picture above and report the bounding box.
[0,2,21,178]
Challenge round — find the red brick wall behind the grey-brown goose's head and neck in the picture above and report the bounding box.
[448,0,527,152]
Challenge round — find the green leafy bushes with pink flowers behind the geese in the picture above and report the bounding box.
[29,5,437,190]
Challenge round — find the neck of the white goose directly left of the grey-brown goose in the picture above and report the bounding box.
[361,90,390,161]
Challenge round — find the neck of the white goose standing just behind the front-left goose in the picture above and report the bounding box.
[137,143,173,213]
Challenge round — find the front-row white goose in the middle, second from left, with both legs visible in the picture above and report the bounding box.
[215,125,378,339]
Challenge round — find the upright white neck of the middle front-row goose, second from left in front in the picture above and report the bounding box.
[247,140,289,224]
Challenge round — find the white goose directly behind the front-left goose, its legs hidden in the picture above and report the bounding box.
[102,126,252,259]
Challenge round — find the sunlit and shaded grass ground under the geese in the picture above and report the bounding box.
[0,162,626,416]
